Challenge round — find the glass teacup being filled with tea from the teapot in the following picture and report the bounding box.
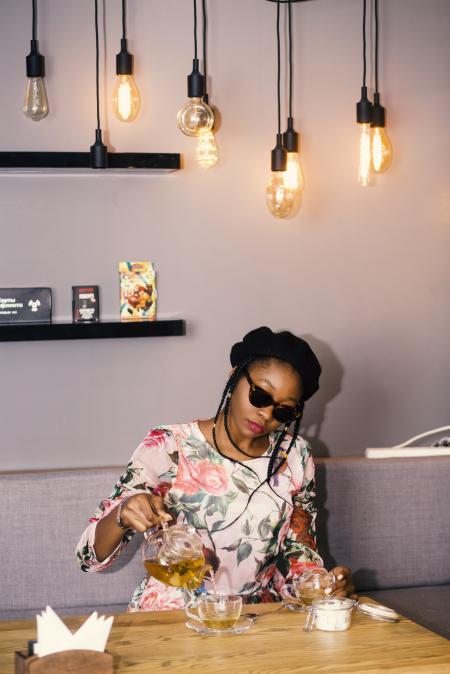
[185,594,242,631]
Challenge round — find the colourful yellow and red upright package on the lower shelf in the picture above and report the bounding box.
[119,262,156,321]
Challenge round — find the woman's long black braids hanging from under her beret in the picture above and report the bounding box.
[212,356,305,483]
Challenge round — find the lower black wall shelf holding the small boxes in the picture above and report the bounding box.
[0,319,186,342]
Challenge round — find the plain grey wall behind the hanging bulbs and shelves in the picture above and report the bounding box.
[0,0,450,470]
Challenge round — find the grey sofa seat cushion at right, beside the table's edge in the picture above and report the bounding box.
[367,585,450,639]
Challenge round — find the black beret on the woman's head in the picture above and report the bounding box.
[230,326,322,400]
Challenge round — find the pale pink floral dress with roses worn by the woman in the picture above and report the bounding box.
[76,422,323,611]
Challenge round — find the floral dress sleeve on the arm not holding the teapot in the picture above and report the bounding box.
[277,445,323,577]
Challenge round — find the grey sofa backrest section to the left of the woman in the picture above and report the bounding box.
[0,467,145,611]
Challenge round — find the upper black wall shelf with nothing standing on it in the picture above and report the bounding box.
[0,152,181,175]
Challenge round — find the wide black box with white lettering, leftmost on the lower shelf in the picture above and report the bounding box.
[0,288,52,323]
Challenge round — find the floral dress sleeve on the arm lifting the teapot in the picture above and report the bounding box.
[76,428,178,571]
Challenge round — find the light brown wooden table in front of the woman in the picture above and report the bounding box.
[0,600,450,674]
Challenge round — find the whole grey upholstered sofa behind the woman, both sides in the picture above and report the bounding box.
[0,457,450,638]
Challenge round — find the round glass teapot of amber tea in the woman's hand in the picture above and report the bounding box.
[141,522,212,590]
